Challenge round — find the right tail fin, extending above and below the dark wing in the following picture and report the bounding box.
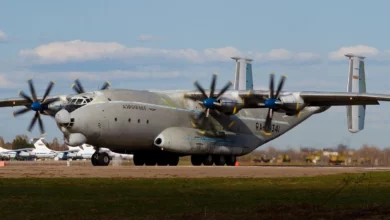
[345,54,366,133]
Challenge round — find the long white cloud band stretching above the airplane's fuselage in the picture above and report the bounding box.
[20,40,320,64]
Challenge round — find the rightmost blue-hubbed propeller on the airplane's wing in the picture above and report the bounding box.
[261,73,287,135]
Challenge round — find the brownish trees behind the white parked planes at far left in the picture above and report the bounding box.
[0,134,68,151]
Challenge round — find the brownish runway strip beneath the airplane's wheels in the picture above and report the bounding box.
[0,162,374,178]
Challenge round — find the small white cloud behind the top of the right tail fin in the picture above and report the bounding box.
[329,45,381,60]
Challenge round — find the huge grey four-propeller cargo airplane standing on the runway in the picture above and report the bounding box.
[0,54,390,166]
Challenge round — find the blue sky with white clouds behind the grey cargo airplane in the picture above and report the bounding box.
[0,0,390,148]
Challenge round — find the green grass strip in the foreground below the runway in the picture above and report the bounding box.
[0,172,390,220]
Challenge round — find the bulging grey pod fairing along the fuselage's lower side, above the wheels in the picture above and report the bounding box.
[154,127,261,156]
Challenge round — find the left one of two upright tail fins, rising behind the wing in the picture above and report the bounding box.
[232,57,253,90]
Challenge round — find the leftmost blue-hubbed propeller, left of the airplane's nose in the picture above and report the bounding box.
[13,79,59,135]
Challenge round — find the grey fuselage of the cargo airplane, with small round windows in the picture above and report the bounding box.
[56,90,321,155]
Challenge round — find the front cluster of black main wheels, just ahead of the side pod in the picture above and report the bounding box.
[133,152,179,166]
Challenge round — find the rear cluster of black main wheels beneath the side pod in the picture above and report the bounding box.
[191,154,237,166]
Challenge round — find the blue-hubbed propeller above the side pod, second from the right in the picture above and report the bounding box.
[187,73,233,134]
